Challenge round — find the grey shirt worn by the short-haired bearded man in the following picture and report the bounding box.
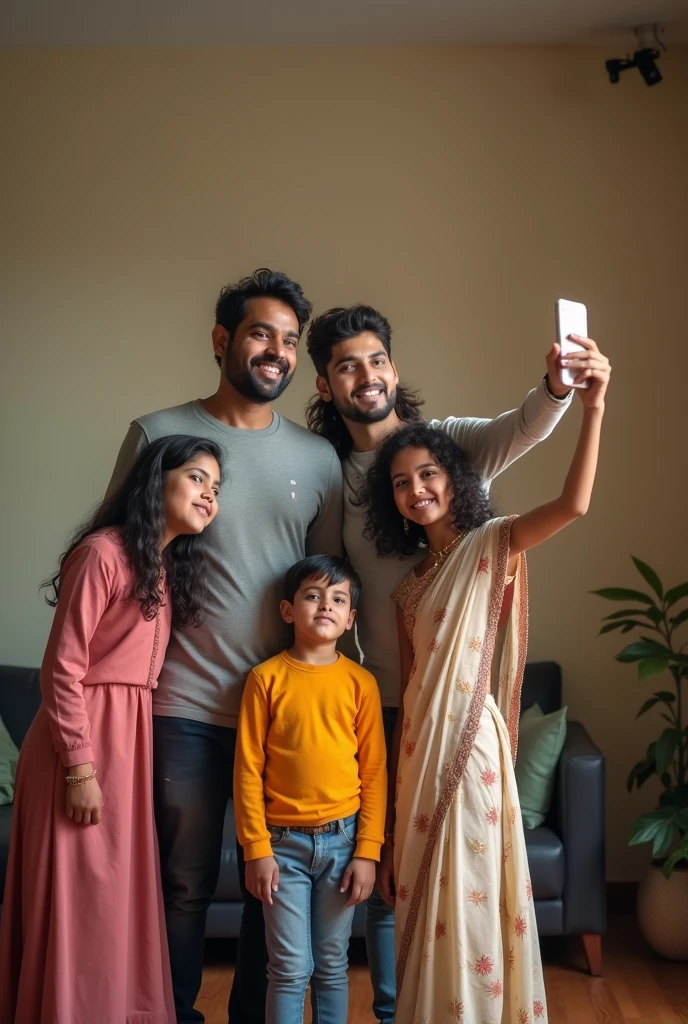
[108,401,342,728]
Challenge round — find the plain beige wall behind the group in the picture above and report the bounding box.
[0,48,688,880]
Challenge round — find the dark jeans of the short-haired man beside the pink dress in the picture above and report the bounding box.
[153,715,267,1024]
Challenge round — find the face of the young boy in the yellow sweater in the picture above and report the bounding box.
[280,579,356,644]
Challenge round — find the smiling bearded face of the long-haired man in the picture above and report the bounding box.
[315,331,399,423]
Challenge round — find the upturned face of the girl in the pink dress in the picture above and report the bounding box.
[163,452,220,544]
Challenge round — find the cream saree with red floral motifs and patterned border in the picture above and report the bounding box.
[394,519,547,1024]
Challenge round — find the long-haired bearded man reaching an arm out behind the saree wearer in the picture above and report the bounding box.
[308,305,609,1024]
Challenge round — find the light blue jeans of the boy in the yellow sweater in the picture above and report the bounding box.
[262,814,356,1024]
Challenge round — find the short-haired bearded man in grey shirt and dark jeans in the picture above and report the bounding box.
[109,270,342,1024]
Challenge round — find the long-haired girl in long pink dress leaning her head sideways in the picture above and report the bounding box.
[0,435,220,1024]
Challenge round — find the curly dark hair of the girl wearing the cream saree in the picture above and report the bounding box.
[359,423,495,558]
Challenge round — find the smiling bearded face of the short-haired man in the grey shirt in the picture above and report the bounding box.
[213,298,299,404]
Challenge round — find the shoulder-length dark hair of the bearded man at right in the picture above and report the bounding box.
[306,304,423,459]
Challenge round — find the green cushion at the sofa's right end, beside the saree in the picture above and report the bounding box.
[516,705,567,828]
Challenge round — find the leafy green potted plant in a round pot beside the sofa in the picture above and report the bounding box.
[594,558,688,961]
